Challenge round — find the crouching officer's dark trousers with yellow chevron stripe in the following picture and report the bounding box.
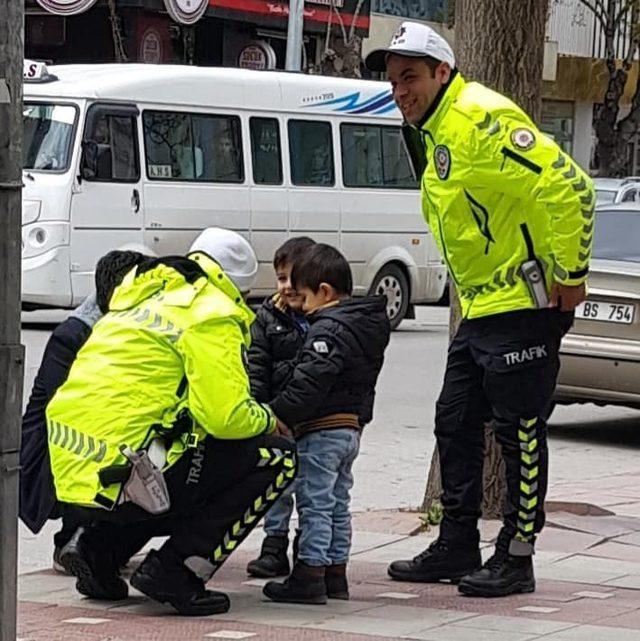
[74,435,297,578]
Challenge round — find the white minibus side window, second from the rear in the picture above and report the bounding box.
[288,120,335,187]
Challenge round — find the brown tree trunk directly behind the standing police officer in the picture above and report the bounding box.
[422,0,548,518]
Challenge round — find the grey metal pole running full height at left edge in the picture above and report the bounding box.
[0,0,24,641]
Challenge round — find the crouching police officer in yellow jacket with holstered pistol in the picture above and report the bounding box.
[47,229,296,615]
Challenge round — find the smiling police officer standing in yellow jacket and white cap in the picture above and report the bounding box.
[366,22,594,596]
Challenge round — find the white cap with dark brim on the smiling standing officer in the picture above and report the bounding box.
[365,22,456,71]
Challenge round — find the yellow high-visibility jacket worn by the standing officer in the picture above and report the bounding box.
[420,74,595,318]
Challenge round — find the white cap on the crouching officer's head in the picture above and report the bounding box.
[189,227,258,293]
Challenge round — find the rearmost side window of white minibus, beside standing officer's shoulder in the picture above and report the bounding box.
[340,123,418,189]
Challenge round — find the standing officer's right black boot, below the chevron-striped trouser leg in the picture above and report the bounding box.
[458,549,536,597]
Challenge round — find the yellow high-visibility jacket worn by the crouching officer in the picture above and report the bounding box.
[47,253,275,508]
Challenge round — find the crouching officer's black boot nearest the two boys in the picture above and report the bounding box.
[130,550,230,616]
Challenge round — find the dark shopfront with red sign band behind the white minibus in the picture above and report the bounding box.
[25,0,370,70]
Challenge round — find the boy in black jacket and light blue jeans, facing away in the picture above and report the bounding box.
[264,244,390,603]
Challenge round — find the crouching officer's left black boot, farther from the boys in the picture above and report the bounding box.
[59,528,129,601]
